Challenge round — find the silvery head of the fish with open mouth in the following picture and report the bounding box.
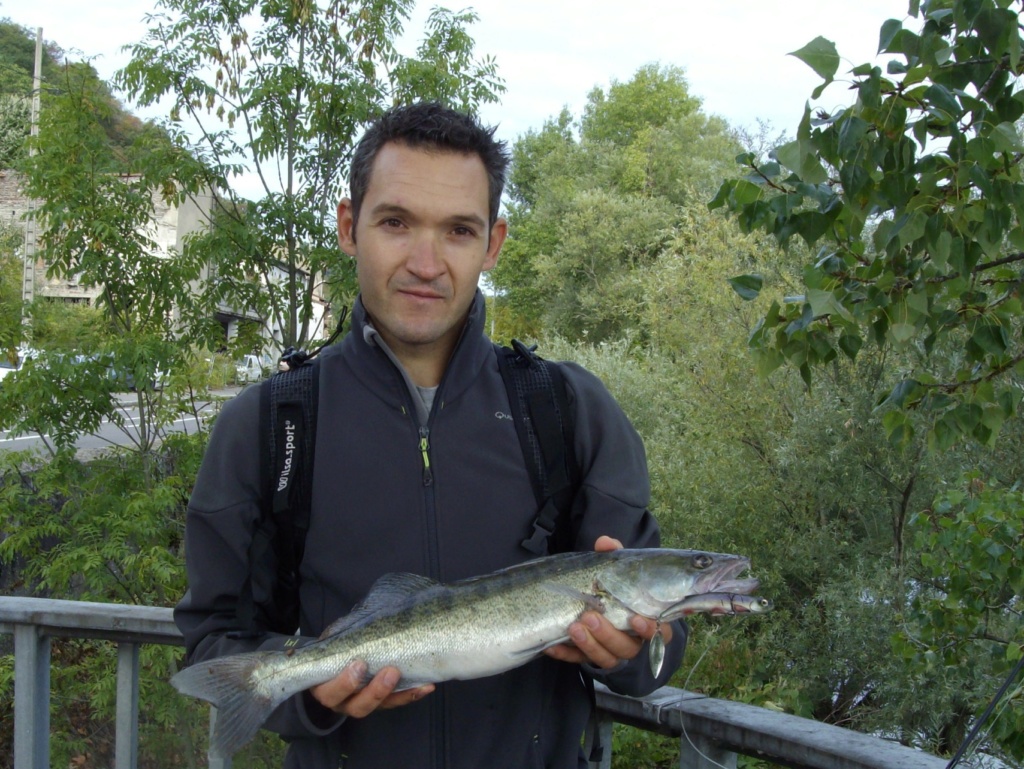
[598,549,758,617]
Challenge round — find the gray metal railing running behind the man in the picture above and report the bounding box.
[0,597,946,769]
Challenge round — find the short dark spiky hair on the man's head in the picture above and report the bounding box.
[348,101,509,226]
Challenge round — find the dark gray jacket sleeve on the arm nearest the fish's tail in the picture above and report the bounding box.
[174,386,343,738]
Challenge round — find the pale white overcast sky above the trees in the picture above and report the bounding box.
[9,0,920,189]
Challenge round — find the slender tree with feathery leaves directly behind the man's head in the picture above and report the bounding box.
[118,0,503,346]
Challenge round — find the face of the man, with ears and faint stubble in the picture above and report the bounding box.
[338,142,507,364]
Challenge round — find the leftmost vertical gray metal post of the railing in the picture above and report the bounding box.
[14,625,50,769]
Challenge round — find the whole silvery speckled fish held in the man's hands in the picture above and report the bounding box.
[171,548,758,760]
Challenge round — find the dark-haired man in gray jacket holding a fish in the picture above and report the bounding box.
[175,104,685,769]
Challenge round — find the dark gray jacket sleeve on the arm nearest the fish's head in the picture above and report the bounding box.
[560,362,688,696]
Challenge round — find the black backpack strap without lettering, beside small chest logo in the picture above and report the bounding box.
[498,339,579,556]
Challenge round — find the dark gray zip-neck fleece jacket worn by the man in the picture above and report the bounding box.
[174,294,685,769]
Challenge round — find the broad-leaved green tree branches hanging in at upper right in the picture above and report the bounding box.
[711,0,1024,447]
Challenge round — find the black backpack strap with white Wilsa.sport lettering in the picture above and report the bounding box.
[236,358,319,633]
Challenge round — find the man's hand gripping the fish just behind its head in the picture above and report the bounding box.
[544,537,672,670]
